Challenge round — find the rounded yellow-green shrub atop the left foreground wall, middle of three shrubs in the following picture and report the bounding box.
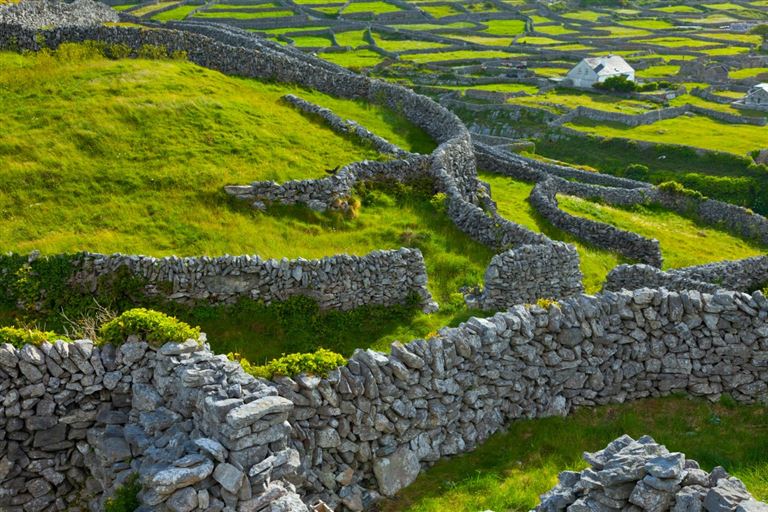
[99,308,200,346]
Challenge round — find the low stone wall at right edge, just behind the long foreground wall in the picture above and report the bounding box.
[604,256,768,292]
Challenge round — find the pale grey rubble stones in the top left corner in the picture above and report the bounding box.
[0,0,120,29]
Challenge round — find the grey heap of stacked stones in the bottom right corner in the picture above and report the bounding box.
[535,435,768,512]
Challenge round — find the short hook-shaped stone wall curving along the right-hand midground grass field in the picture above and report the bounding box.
[530,178,662,267]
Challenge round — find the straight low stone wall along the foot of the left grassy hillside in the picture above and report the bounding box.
[70,249,437,311]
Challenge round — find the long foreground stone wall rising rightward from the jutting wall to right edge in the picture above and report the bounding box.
[276,289,768,510]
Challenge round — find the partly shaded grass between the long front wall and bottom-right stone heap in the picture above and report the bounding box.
[379,397,768,512]
